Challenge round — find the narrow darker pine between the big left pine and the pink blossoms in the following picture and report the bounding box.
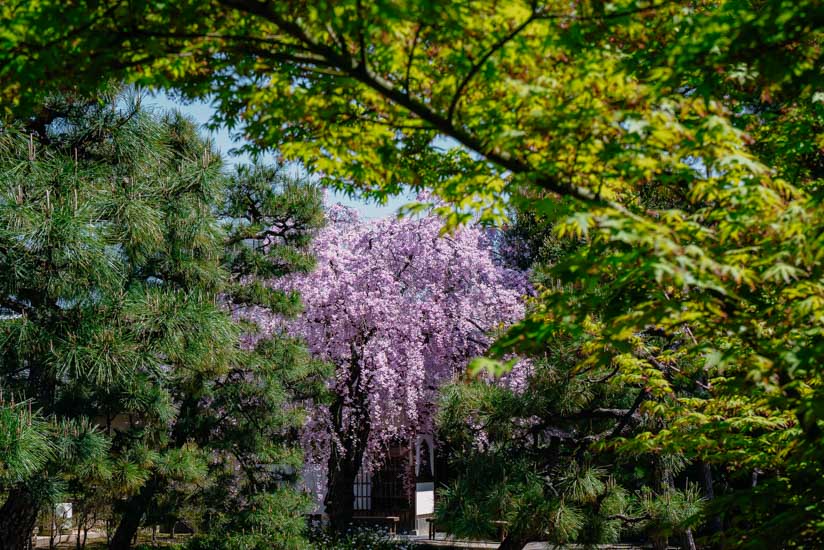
[180,165,331,550]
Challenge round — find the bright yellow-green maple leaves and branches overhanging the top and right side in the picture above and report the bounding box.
[0,0,824,545]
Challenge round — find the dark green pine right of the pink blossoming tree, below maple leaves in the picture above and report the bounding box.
[438,205,702,549]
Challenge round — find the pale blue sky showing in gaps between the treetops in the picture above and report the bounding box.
[144,94,412,219]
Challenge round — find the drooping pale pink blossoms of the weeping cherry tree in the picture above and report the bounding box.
[277,206,529,480]
